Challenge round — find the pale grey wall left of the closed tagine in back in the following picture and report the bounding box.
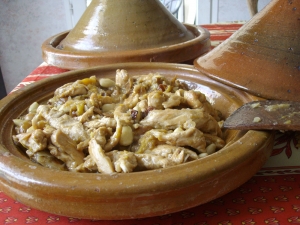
[0,0,70,92]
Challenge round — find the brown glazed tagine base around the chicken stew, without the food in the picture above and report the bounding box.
[0,63,274,220]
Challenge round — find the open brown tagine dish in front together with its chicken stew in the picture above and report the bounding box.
[0,63,274,220]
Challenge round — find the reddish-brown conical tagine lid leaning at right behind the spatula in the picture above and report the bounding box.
[194,0,300,101]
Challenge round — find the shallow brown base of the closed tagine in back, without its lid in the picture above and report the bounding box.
[42,24,210,69]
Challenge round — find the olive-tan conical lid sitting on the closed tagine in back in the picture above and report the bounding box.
[57,0,195,51]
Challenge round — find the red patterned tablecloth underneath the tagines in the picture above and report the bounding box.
[0,24,300,225]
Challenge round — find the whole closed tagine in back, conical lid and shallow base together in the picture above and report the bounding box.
[42,0,210,69]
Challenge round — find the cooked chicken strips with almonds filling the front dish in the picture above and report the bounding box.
[13,70,225,174]
